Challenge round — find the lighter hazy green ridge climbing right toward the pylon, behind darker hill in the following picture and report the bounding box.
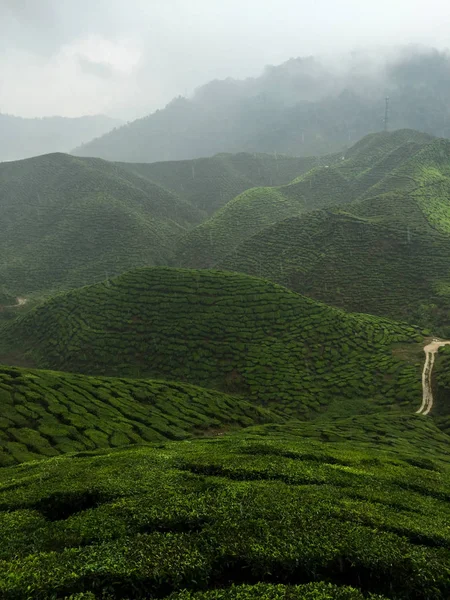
[176,130,432,268]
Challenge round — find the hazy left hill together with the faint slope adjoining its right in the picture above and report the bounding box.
[0,149,320,298]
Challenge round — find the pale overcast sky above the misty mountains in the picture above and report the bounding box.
[0,0,450,119]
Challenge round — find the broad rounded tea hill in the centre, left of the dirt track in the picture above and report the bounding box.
[0,268,422,415]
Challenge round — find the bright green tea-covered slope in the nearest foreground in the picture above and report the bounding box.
[0,417,450,600]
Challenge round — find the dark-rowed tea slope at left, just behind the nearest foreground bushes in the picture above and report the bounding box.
[0,367,274,467]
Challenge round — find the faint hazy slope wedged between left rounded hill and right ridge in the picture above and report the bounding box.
[120,153,338,215]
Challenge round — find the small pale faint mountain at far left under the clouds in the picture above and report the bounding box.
[0,113,122,162]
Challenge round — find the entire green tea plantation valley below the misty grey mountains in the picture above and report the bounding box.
[0,129,450,600]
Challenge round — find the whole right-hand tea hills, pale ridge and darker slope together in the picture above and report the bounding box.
[175,130,450,336]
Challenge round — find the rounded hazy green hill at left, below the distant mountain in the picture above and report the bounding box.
[0,154,202,296]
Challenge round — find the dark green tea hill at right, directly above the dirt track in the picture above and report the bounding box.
[218,207,450,335]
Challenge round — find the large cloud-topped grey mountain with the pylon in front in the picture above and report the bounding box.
[74,50,450,162]
